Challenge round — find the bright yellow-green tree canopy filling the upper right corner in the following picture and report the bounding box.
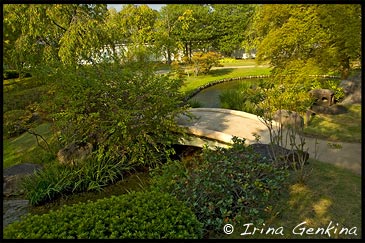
[251,4,361,78]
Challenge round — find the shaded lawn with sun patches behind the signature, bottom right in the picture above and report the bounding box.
[215,160,362,239]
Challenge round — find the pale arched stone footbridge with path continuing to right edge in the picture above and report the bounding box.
[177,108,361,173]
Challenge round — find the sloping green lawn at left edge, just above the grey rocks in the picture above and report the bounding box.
[3,123,53,168]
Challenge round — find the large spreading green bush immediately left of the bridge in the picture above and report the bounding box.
[44,62,185,166]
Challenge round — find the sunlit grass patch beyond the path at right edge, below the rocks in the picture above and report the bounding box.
[304,104,361,143]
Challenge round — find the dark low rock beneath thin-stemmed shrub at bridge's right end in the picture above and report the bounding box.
[249,143,309,167]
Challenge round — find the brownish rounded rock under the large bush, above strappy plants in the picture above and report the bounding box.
[57,143,93,165]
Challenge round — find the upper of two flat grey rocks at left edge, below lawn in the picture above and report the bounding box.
[3,163,42,197]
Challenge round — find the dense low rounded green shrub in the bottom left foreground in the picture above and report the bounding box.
[4,192,202,239]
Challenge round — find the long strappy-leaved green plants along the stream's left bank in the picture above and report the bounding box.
[22,157,130,205]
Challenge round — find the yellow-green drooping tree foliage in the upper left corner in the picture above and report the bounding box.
[3,4,107,68]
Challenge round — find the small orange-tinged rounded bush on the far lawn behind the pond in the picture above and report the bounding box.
[191,52,221,76]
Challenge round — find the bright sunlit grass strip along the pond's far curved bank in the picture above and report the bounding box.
[181,67,270,94]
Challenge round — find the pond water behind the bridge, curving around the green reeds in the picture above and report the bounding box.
[190,79,262,108]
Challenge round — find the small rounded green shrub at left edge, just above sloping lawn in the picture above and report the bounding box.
[3,110,32,137]
